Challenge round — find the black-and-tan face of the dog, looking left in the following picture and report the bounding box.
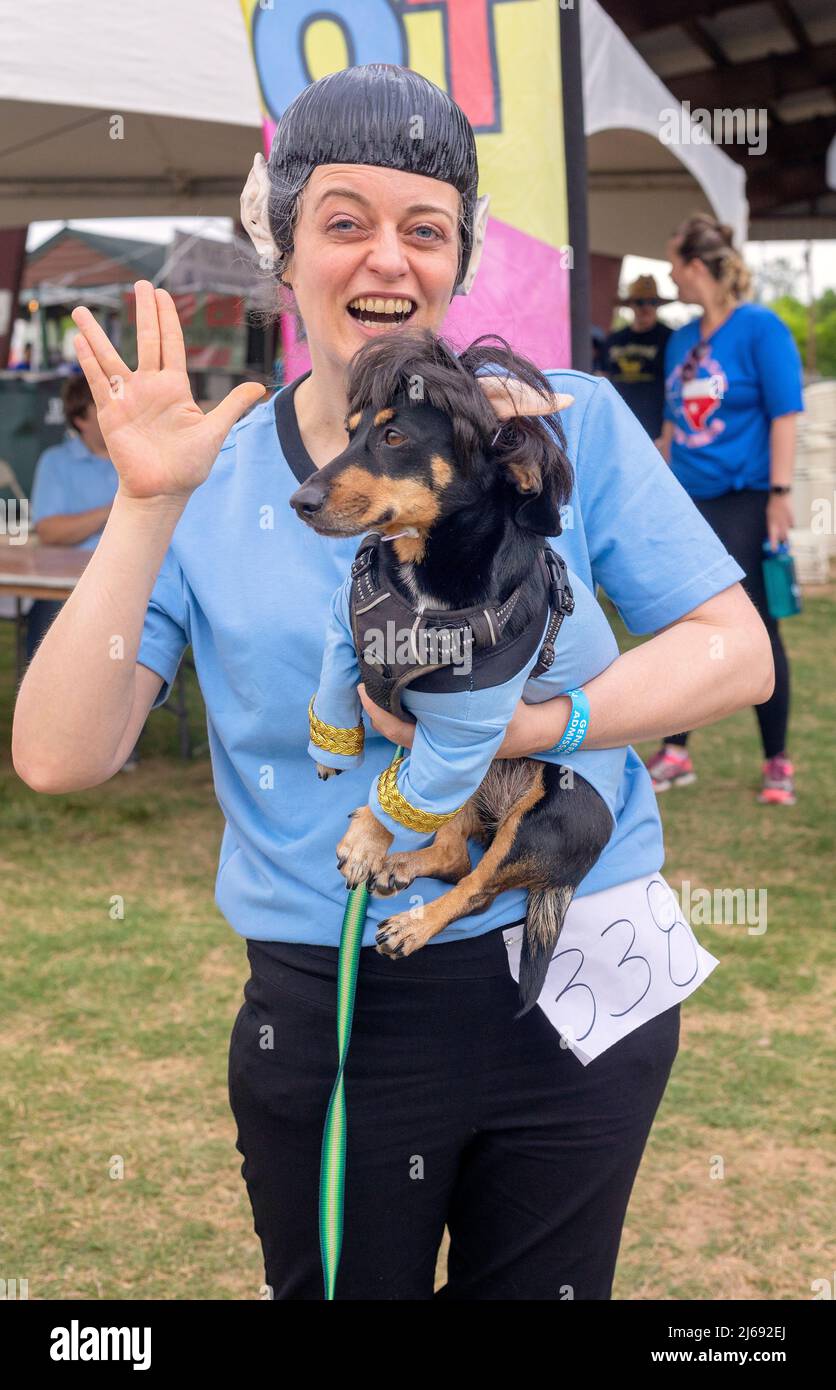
[291,394,476,559]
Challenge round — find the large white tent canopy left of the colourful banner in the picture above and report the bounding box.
[0,0,262,227]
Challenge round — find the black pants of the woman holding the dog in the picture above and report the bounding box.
[230,927,679,1301]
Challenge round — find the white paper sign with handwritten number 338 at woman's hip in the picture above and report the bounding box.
[502,873,719,1066]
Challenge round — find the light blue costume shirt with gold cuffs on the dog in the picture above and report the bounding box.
[307,558,627,853]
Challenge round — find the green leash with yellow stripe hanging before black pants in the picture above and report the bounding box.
[320,748,403,1301]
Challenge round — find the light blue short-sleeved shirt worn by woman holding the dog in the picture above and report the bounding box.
[138,371,743,945]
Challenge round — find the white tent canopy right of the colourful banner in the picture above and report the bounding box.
[580,0,748,259]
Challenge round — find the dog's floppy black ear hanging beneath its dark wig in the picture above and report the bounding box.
[494,416,572,535]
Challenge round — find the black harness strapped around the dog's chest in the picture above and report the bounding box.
[344,531,574,717]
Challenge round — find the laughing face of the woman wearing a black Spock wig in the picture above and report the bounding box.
[284,164,460,367]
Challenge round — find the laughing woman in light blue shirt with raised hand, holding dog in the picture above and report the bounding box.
[13,64,772,1300]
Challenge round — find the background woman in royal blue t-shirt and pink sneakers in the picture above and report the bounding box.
[648,215,804,805]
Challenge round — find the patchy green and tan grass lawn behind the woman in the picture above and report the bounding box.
[0,572,836,1300]
